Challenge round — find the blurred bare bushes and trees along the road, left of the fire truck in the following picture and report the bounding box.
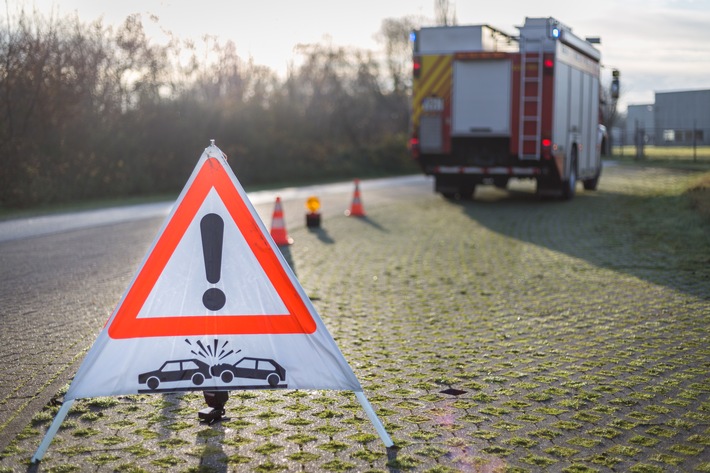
[0,12,413,208]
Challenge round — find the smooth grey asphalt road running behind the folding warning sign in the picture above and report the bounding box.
[0,175,432,451]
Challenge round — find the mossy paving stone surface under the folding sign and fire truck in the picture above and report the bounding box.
[0,166,710,472]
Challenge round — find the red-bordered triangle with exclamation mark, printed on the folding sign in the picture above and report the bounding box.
[108,149,316,339]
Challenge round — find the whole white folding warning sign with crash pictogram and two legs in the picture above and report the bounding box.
[32,143,393,461]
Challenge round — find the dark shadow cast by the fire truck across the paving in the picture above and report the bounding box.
[450,180,710,299]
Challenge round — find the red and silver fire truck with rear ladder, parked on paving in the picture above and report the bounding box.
[410,18,602,199]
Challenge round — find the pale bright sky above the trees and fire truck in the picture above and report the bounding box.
[13,0,710,109]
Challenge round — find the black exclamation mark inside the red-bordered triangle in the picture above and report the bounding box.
[200,214,227,310]
